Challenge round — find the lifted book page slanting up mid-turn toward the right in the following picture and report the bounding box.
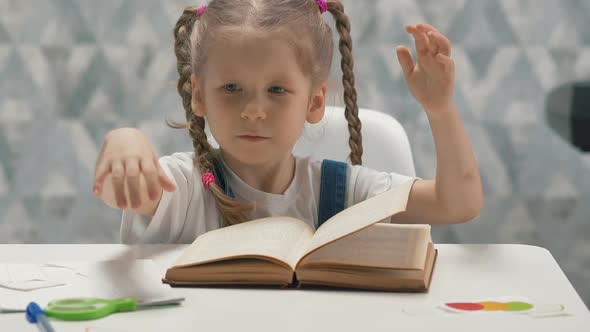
[306,179,416,264]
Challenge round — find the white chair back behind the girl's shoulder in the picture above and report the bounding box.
[294,106,416,176]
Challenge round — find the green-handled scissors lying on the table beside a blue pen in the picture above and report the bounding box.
[43,297,180,320]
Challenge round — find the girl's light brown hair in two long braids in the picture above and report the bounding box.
[168,0,363,225]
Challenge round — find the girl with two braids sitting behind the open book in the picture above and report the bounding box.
[94,0,483,243]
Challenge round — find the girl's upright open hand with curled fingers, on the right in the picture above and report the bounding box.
[396,24,455,112]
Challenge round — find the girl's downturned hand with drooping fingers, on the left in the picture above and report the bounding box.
[93,128,176,211]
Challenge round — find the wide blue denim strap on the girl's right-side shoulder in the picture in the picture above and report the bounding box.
[318,159,348,227]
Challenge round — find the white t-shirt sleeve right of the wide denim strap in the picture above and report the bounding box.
[347,165,413,213]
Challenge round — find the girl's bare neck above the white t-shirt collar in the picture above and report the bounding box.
[220,150,295,194]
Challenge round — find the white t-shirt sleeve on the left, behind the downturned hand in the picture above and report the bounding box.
[121,153,196,244]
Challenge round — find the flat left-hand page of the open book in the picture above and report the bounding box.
[174,217,313,269]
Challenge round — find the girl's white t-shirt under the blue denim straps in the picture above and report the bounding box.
[121,152,411,243]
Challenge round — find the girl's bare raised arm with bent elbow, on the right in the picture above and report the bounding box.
[392,24,483,224]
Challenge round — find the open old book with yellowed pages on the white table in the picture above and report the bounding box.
[163,180,437,291]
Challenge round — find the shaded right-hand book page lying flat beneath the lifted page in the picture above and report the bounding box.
[301,223,431,270]
